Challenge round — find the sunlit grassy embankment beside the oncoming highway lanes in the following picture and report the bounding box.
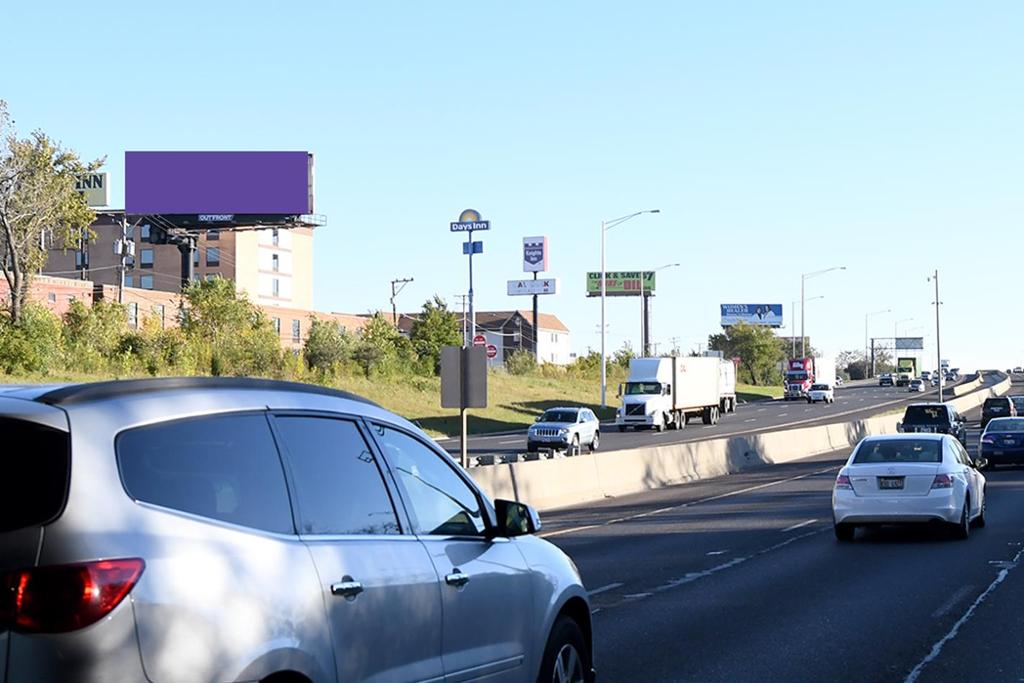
[0,369,622,436]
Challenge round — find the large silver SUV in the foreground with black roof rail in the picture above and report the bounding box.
[0,378,593,683]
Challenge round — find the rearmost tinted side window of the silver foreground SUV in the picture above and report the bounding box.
[117,414,295,533]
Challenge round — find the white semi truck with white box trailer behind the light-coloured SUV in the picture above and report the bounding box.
[615,357,736,431]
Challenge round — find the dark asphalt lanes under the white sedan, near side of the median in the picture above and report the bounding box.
[542,386,1024,682]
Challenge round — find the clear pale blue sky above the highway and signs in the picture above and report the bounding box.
[0,0,1024,369]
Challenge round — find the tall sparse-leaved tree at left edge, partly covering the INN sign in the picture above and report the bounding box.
[0,100,102,323]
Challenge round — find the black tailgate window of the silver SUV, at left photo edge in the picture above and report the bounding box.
[0,418,71,532]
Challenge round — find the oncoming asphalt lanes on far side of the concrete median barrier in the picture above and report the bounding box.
[438,373,987,458]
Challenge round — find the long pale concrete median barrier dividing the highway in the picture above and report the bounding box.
[469,378,1011,510]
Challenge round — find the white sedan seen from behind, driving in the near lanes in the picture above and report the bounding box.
[833,434,985,541]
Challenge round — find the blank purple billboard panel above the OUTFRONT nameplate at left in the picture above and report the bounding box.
[125,152,313,216]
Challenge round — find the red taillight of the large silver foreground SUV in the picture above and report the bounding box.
[0,558,145,633]
